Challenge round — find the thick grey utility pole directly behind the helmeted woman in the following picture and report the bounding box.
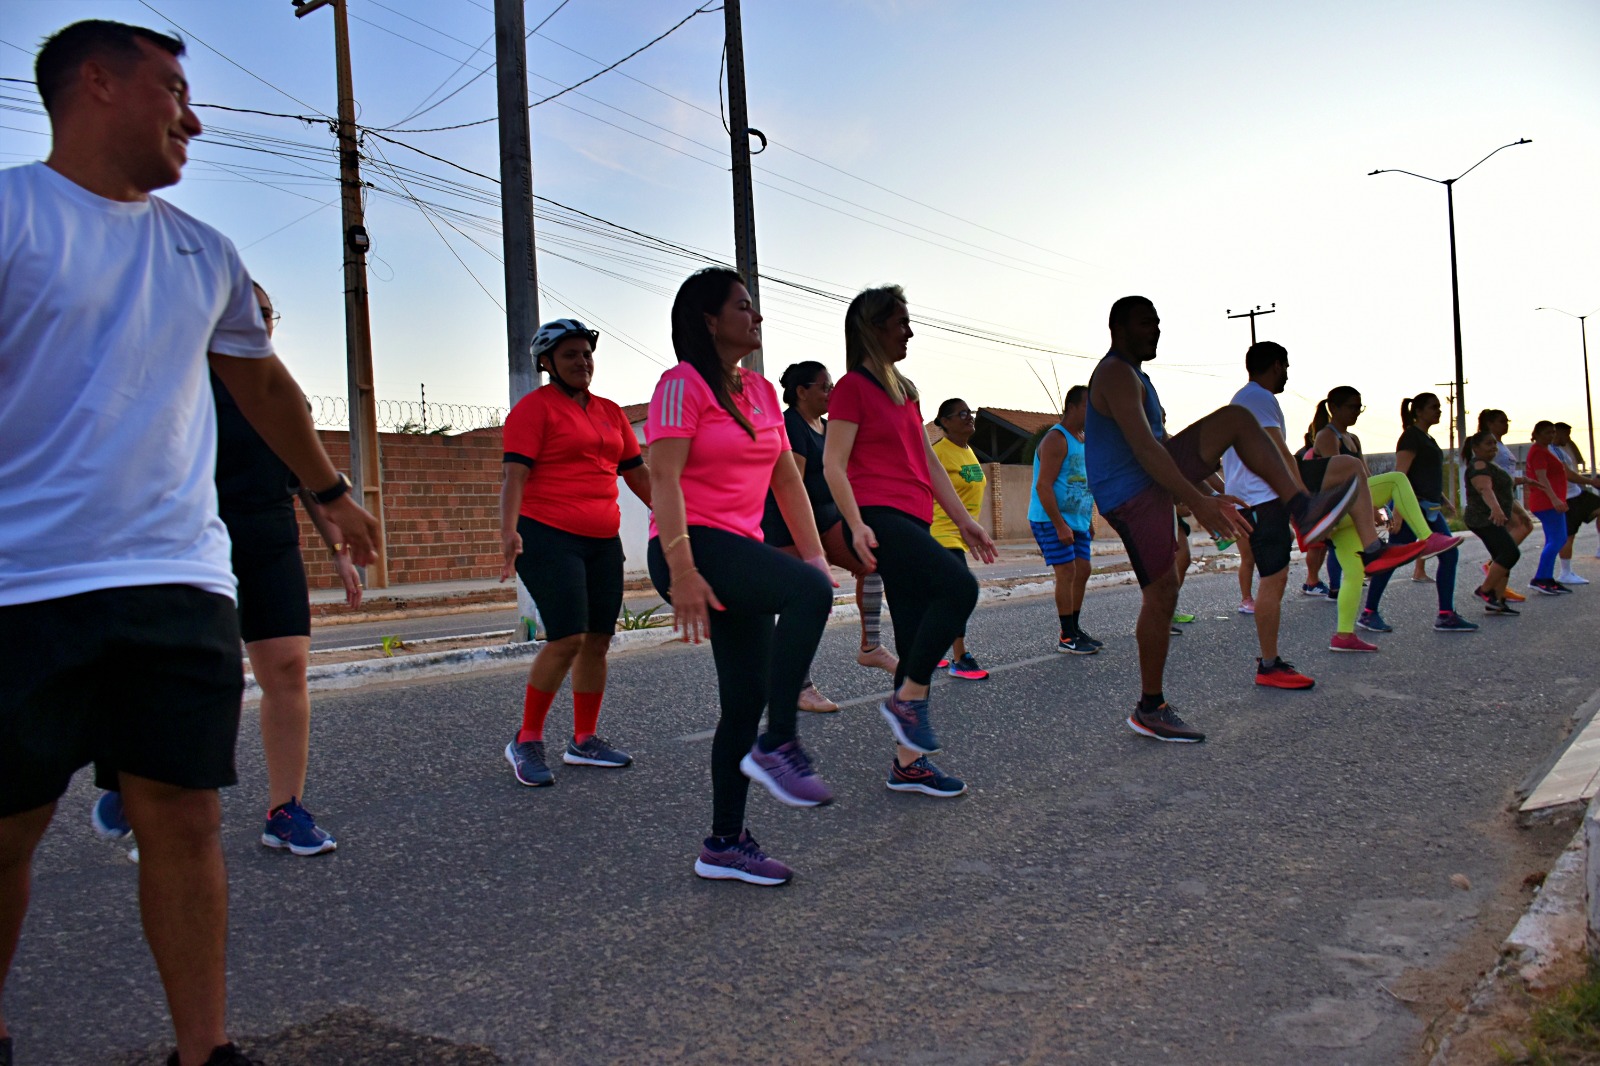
[494,0,539,640]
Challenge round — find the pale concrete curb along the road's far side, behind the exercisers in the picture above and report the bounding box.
[272,555,1238,699]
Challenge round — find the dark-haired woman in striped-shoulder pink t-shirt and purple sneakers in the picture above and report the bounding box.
[645,267,835,885]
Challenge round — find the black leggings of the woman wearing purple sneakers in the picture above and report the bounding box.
[648,525,834,837]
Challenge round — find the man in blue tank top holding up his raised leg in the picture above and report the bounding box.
[1085,296,1357,744]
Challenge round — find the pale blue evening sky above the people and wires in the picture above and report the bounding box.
[0,0,1600,451]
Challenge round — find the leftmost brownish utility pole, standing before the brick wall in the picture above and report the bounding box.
[294,0,389,589]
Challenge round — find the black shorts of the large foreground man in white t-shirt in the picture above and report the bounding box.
[0,584,245,818]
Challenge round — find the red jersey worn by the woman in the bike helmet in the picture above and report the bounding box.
[504,384,643,538]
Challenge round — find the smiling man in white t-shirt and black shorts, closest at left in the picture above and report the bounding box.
[0,21,378,1066]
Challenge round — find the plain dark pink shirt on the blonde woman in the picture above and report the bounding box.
[827,370,942,523]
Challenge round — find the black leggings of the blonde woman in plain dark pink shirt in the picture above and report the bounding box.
[861,507,978,690]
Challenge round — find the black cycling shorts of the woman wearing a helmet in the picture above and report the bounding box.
[517,515,622,640]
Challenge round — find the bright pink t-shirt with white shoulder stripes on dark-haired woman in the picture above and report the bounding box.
[645,363,789,541]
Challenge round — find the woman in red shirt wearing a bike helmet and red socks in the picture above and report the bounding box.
[501,319,650,787]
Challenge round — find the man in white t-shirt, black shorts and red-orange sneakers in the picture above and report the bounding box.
[1222,341,1315,688]
